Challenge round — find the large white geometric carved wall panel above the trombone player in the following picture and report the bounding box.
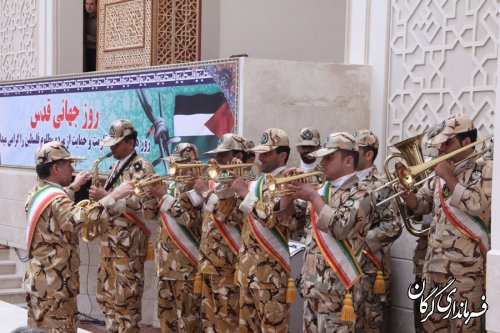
[387,0,500,149]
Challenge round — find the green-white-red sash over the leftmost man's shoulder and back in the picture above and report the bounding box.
[26,185,68,250]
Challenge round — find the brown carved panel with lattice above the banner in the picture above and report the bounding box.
[97,0,201,70]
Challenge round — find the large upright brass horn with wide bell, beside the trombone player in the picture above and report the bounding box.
[377,133,429,237]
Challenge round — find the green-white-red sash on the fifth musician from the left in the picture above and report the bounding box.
[247,175,292,275]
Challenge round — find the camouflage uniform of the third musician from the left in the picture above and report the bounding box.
[156,183,202,333]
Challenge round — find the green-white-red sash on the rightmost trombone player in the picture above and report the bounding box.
[437,177,490,256]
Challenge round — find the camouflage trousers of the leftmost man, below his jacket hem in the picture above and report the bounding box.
[26,294,78,333]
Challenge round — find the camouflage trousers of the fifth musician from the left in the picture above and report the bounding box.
[239,287,290,333]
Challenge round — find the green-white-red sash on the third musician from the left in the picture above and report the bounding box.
[160,183,201,266]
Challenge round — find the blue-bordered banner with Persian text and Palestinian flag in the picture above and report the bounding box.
[0,59,238,174]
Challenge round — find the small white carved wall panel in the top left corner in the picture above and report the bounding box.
[0,0,38,81]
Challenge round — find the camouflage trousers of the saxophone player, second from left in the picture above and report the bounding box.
[96,256,145,333]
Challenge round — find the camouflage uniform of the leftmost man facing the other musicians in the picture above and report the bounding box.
[23,143,114,333]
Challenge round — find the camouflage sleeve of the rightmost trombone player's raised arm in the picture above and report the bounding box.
[450,158,493,216]
